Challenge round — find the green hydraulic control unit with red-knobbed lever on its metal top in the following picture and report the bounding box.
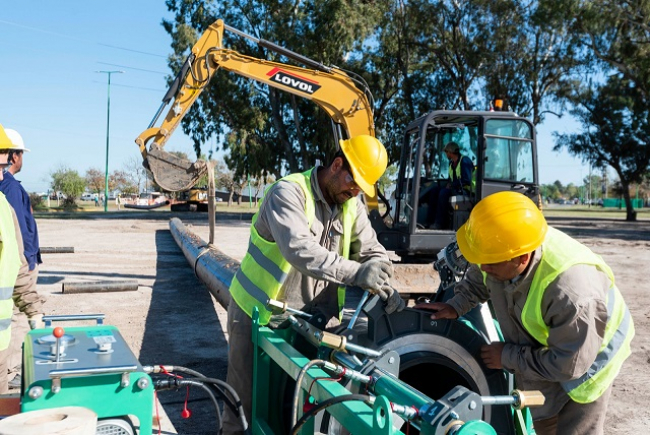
[21,314,154,435]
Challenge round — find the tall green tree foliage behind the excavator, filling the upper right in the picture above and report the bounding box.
[158,0,650,204]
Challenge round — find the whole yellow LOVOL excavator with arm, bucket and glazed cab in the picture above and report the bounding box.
[136,20,539,294]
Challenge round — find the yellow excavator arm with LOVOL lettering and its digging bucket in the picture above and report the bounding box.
[135,20,375,191]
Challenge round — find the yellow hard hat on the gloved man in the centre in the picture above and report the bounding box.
[339,134,388,196]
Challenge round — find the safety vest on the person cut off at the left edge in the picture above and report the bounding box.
[0,192,20,350]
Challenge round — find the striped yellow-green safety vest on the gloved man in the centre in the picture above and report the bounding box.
[230,168,357,325]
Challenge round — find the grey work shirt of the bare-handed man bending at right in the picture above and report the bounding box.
[448,240,610,420]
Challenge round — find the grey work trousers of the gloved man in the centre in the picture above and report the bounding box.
[223,298,253,435]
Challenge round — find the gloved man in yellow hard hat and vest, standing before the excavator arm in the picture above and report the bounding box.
[224,135,404,434]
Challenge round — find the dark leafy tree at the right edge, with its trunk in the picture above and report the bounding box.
[554,74,650,221]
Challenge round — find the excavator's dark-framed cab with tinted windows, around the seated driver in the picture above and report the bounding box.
[371,111,539,263]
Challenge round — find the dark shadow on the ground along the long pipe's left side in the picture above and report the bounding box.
[140,230,228,435]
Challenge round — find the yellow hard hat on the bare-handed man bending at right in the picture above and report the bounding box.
[456,192,548,264]
